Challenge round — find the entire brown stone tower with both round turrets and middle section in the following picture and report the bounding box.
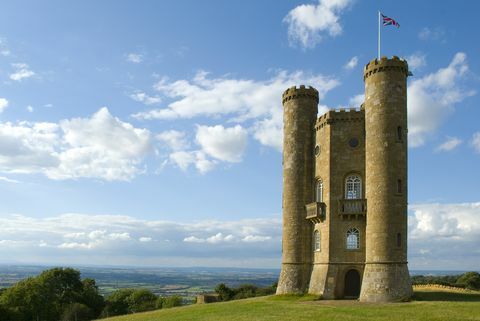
[277,57,412,302]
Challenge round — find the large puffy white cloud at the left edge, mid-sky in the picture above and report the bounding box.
[0,107,151,180]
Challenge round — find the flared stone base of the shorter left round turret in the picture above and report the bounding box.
[276,263,312,295]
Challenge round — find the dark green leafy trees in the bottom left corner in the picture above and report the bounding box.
[0,268,182,321]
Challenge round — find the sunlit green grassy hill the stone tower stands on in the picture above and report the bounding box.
[103,287,480,321]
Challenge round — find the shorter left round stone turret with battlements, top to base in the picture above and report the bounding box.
[277,86,318,294]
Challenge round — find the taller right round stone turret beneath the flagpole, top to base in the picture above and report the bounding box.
[360,56,413,302]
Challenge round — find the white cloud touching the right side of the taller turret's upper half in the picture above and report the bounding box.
[408,52,475,147]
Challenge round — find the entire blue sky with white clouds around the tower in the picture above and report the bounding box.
[0,0,480,270]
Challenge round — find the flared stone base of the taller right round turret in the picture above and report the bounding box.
[360,262,413,302]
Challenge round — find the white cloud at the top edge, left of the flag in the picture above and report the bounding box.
[283,0,353,48]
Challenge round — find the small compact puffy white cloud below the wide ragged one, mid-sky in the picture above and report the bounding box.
[196,125,247,163]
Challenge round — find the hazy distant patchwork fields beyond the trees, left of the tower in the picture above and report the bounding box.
[0,265,279,301]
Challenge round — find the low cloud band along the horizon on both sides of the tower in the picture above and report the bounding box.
[0,202,480,270]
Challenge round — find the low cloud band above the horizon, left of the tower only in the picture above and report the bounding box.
[0,214,281,267]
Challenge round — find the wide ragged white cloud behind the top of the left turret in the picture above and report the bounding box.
[133,71,339,152]
